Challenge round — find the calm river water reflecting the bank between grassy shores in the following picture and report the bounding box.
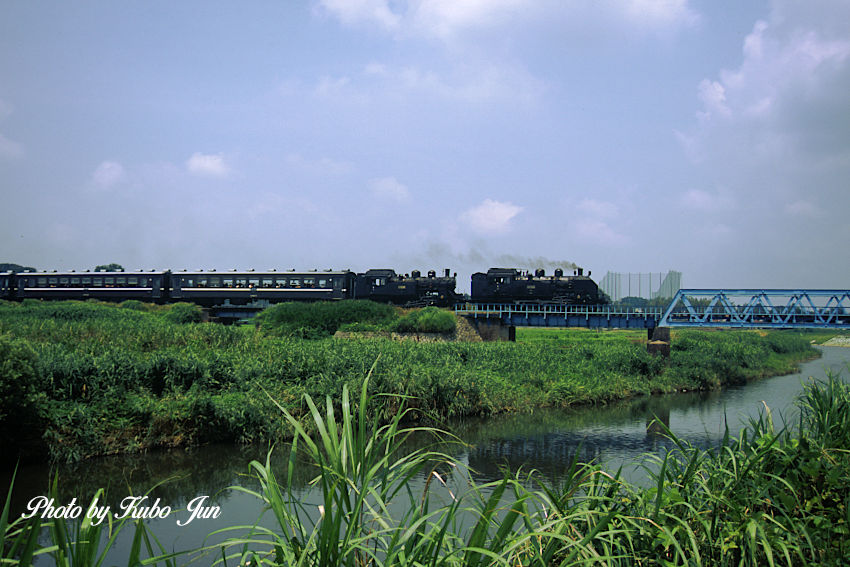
[6,347,850,565]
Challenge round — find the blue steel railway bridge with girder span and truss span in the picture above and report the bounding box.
[455,289,850,330]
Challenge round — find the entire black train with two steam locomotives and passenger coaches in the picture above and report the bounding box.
[0,268,604,307]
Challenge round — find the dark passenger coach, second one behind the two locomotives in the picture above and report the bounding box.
[16,271,168,303]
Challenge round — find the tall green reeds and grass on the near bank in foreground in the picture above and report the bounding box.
[6,377,850,567]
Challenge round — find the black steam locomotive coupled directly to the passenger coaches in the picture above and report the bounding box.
[353,269,459,307]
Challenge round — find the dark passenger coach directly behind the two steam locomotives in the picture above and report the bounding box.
[169,271,354,307]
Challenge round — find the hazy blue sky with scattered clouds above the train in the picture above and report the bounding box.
[0,0,850,291]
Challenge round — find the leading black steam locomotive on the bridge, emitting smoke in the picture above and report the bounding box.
[472,268,601,305]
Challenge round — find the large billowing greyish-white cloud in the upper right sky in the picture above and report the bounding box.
[676,0,850,238]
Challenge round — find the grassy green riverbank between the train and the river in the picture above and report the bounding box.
[0,302,828,460]
